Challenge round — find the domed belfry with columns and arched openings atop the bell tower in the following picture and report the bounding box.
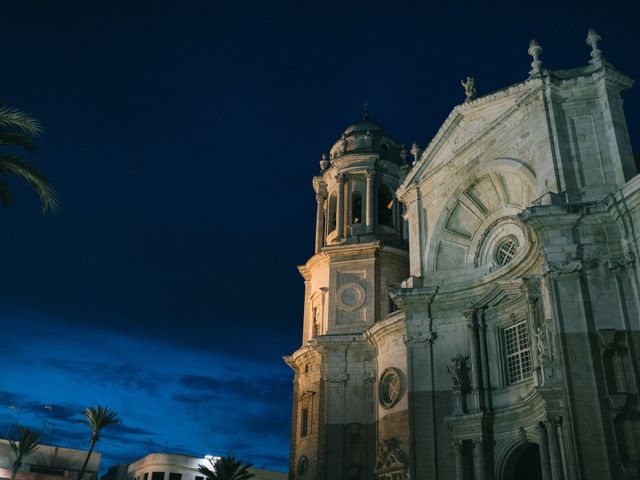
[313,114,408,253]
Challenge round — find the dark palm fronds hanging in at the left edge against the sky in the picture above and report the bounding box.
[0,107,60,213]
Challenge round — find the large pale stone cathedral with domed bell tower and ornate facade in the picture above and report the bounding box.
[285,30,640,480]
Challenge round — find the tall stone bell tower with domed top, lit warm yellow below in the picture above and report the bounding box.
[285,114,409,480]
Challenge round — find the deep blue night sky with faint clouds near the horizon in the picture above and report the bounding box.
[0,0,640,471]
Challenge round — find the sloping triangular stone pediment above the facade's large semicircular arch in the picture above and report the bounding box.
[399,79,542,197]
